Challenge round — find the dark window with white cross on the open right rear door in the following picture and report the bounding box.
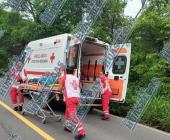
[112,56,127,74]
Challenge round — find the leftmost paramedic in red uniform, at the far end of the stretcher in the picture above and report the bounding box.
[10,75,24,111]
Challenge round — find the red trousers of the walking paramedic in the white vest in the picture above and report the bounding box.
[65,97,86,135]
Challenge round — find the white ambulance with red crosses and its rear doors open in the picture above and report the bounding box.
[22,34,131,102]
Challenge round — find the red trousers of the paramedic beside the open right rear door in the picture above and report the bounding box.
[102,89,112,117]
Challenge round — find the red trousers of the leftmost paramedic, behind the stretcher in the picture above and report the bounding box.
[10,87,24,107]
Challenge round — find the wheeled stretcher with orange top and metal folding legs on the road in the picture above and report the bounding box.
[20,76,61,124]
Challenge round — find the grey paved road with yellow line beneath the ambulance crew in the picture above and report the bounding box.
[0,98,170,140]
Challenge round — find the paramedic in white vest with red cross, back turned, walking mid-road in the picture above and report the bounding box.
[60,69,86,140]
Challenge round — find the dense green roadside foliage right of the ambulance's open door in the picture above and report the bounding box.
[111,0,170,132]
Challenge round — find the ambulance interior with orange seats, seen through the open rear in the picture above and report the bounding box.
[66,39,107,83]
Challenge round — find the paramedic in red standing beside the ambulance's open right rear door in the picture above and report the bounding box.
[99,72,112,120]
